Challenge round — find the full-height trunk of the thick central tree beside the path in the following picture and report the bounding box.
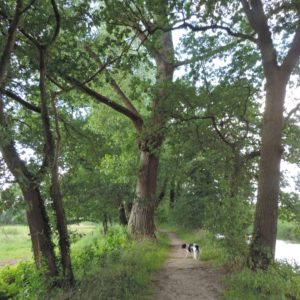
[128,13,174,238]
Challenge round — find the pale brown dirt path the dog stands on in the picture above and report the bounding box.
[153,233,224,300]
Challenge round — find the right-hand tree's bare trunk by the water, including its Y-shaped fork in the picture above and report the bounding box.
[241,0,300,269]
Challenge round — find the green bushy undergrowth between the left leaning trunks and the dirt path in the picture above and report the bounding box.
[51,226,166,300]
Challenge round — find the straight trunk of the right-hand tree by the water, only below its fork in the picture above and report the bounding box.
[249,76,285,269]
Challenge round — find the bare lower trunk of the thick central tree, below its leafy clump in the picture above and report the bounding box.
[128,151,159,238]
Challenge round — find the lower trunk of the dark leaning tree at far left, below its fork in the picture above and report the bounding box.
[22,187,58,276]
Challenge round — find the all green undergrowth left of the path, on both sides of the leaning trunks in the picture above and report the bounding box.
[0,226,167,300]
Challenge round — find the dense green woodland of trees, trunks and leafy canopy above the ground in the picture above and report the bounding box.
[0,0,300,299]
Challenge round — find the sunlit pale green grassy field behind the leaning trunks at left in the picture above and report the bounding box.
[0,223,97,268]
